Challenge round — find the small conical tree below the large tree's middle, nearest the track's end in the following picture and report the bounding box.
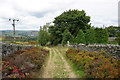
[61,29,73,45]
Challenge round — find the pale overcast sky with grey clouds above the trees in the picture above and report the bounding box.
[0,0,120,30]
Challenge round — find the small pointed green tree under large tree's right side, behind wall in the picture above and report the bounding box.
[75,29,85,44]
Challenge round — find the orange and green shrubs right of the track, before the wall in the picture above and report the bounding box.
[66,49,119,78]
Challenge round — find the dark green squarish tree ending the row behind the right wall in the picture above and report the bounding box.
[95,28,109,44]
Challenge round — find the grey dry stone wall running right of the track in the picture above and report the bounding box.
[68,44,120,59]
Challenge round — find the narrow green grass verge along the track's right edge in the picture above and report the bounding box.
[56,47,84,78]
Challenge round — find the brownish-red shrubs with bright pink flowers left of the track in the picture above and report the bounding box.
[2,47,49,78]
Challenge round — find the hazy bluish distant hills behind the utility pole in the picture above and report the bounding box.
[0,30,39,37]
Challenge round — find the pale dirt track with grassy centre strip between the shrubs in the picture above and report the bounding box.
[39,48,76,78]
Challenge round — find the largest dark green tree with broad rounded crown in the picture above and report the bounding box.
[49,10,90,44]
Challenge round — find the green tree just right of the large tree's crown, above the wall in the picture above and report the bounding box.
[85,28,96,44]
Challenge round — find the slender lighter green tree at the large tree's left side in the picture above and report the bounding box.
[38,26,49,46]
